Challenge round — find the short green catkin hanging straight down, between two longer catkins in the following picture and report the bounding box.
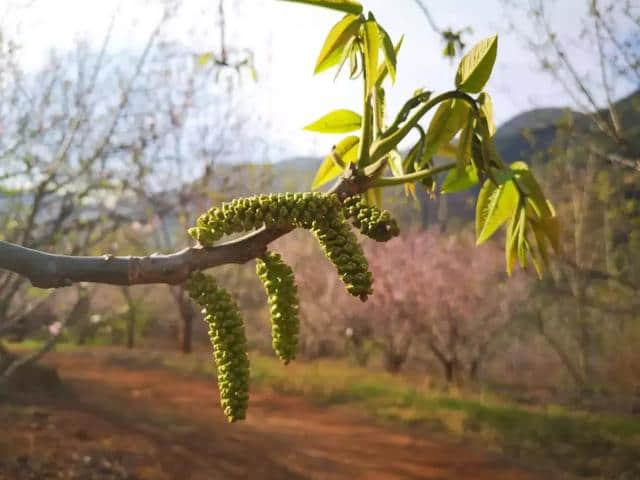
[256,252,300,364]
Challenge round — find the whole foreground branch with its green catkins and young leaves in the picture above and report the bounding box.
[0,0,558,421]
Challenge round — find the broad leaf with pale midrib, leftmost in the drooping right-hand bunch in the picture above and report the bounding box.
[476,176,520,245]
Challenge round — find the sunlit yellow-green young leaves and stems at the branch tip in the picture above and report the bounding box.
[288,0,559,275]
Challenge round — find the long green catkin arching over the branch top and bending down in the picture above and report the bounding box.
[189,192,372,301]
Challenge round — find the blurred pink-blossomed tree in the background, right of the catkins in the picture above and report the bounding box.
[367,230,528,382]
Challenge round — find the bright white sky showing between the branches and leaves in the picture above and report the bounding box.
[0,0,632,161]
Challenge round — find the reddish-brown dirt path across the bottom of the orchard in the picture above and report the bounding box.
[0,354,537,480]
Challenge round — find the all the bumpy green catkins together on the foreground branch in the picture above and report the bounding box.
[186,189,398,421]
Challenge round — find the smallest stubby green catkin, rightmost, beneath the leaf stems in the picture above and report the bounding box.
[343,196,400,242]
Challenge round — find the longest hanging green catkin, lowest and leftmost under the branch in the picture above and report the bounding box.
[185,272,249,422]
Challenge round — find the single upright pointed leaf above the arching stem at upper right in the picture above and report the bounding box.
[455,35,498,93]
